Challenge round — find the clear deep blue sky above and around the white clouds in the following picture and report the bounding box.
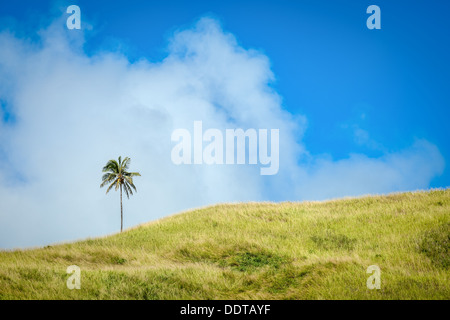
[1,1,450,187]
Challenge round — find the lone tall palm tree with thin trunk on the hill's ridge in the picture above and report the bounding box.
[100,157,141,232]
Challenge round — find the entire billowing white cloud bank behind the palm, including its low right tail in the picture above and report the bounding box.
[0,18,444,248]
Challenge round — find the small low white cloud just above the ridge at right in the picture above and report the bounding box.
[297,140,444,199]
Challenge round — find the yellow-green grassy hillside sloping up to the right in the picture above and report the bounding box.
[0,189,450,299]
